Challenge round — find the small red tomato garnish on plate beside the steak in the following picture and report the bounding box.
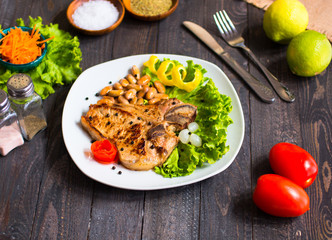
[91,139,118,164]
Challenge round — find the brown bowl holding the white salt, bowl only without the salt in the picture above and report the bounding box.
[67,0,125,35]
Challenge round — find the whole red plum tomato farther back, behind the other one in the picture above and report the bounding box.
[269,143,318,188]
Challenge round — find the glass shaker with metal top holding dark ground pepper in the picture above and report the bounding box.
[7,73,47,141]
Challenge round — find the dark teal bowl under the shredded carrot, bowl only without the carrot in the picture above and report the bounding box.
[0,27,47,72]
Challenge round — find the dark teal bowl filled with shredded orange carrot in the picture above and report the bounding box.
[0,27,51,72]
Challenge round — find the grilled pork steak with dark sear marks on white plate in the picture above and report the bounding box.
[81,98,197,170]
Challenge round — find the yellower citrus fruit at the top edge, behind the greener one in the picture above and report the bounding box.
[263,0,309,44]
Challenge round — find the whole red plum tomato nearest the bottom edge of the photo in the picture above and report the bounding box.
[253,174,310,217]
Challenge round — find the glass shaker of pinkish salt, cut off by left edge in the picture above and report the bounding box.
[0,90,24,156]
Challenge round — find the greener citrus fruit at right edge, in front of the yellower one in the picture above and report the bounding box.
[287,30,332,77]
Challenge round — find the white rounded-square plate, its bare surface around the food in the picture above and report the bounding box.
[62,54,244,190]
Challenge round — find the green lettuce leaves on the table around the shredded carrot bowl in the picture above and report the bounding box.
[0,17,82,99]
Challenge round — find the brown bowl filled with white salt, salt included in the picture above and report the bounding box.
[67,0,125,35]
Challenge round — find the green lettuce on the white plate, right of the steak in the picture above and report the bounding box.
[152,61,233,178]
